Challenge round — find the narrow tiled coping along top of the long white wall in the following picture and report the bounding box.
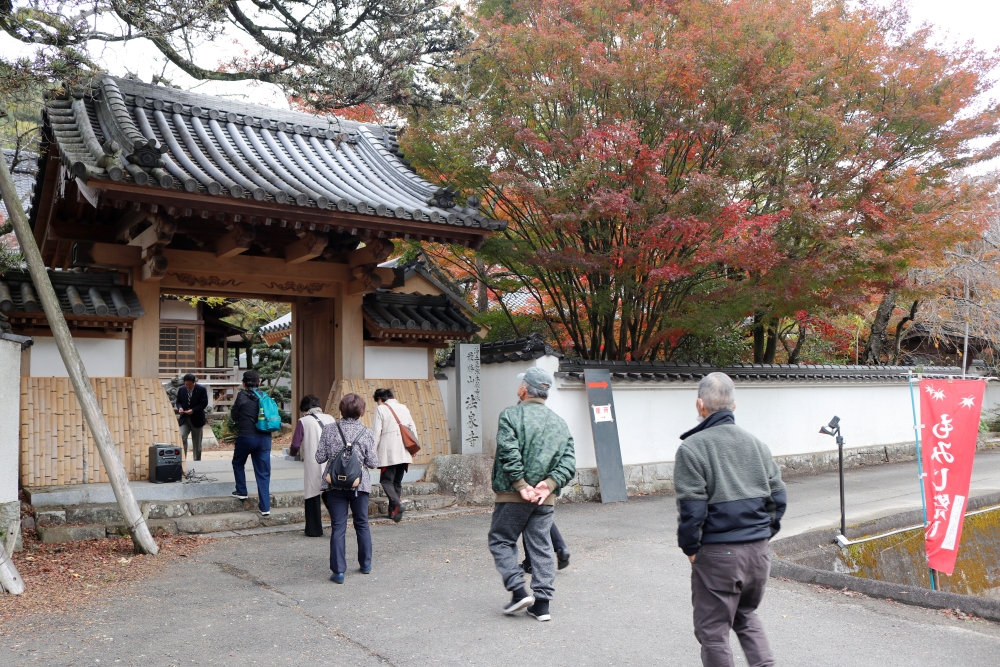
[559,359,962,382]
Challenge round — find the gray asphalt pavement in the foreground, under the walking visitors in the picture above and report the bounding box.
[0,487,1000,667]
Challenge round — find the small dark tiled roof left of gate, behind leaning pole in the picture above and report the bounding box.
[0,271,146,322]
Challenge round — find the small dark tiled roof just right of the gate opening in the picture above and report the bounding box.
[362,292,479,340]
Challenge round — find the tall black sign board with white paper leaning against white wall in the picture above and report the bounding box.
[583,368,628,503]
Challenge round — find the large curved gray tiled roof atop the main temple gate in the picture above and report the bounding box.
[46,77,506,233]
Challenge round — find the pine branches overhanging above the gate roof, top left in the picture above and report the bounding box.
[0,0,468,111]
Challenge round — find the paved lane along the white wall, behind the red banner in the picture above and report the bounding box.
[782,450,1000,536]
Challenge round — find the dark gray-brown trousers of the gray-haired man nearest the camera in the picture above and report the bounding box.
[691,540,774,667]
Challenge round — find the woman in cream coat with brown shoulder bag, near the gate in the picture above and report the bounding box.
[372,389,417,523]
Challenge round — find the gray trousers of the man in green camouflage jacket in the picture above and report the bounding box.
[489,503,556,600]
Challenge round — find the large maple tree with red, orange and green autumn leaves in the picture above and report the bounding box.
[404,0,1000,361]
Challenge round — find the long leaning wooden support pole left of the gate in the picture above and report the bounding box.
[0,153,159,568]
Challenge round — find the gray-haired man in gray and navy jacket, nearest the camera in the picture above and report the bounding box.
[674,373,785,667]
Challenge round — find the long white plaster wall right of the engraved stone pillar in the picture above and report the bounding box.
[464,357,940,468]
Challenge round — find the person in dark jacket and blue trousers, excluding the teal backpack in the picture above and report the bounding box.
[230,371,271,516]
